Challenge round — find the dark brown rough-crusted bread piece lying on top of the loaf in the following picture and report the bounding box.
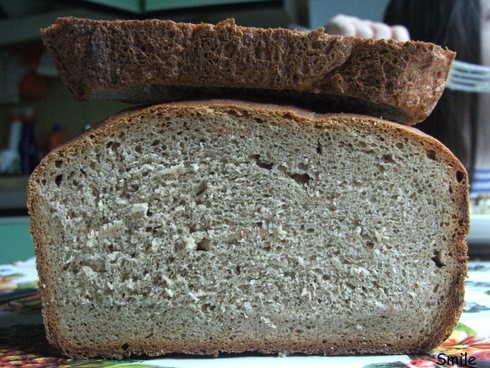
[43,17,455,125]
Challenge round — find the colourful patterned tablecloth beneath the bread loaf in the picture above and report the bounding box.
[0,259,490,368]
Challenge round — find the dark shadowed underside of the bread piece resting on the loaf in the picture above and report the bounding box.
[91,85,411,125]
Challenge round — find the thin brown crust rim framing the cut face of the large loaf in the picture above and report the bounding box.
[27,100,469,358]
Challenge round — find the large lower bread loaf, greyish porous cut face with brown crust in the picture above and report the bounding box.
[29,101,468,357]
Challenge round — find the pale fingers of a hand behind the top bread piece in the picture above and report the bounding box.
[325,14,410,41]
